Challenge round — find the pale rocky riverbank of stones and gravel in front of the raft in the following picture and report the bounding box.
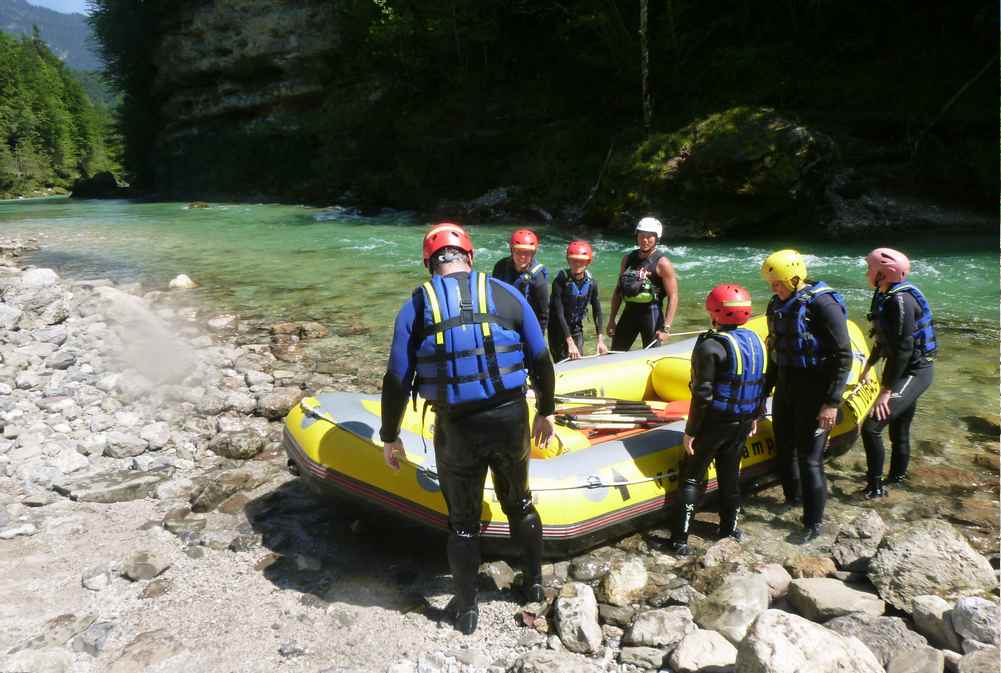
[0,241,999,673]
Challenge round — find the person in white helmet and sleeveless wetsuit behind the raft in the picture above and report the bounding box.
[606,217,679,351]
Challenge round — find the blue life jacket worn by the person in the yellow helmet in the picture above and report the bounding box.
[767,281,848,369]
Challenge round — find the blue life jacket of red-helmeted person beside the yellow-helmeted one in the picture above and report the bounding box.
[699,327,765,420]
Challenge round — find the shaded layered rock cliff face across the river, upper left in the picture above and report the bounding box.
[152,0,338,201]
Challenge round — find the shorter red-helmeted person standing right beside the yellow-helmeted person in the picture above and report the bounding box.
[668,284,765,556]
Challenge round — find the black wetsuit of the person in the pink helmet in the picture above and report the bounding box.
[862,292,935,483]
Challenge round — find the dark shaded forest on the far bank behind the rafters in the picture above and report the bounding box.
[91,0,998,220]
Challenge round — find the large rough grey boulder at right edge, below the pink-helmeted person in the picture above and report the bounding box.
[869,519,997,611]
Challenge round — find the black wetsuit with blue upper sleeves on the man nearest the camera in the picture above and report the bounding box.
[379,272,556,614]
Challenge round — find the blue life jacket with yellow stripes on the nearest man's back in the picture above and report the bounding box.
[416,271,528,409]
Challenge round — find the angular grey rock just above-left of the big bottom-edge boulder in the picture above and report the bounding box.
[692,575,770,645]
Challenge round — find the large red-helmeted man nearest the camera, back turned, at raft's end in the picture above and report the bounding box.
[379,222,556,634]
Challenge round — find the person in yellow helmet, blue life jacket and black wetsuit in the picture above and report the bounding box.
[761,249,852,542]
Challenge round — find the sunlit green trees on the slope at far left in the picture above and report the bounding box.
[0,31,113,196]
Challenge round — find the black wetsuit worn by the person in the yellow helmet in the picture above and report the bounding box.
[765,286,852,528]
